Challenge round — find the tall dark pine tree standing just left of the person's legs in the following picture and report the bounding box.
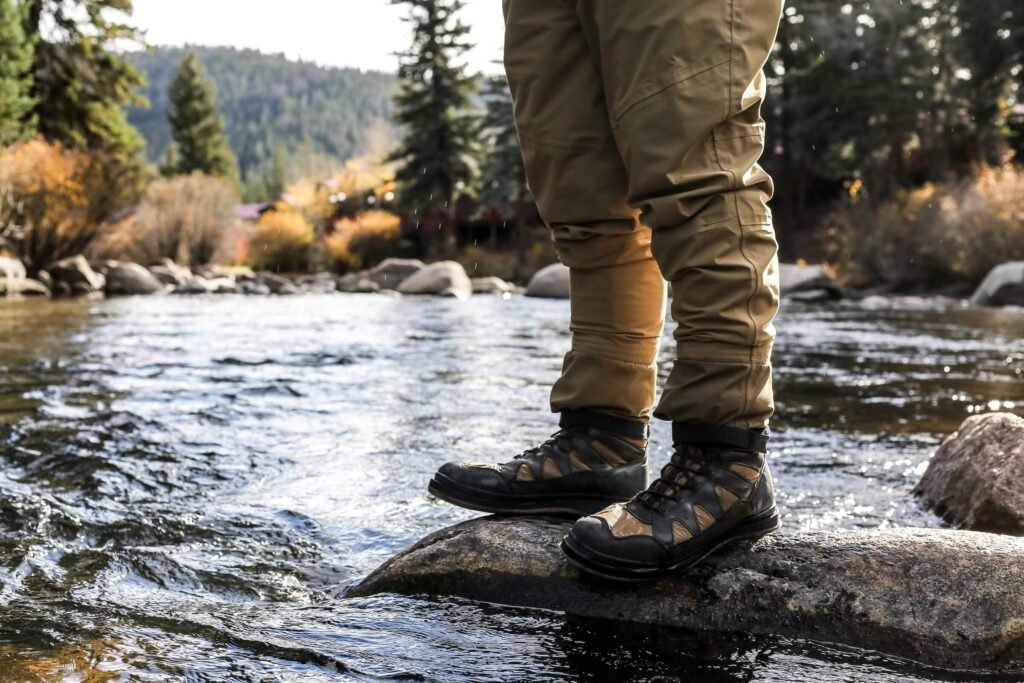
[390,0,478,252]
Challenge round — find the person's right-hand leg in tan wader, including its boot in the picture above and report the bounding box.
[566,0,782,577]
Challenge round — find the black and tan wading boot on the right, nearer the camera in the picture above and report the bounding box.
[562,423,779,581]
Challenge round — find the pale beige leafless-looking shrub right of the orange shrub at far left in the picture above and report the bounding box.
[125,173,239,265]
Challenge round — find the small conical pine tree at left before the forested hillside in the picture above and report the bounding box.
[167,52,238,178]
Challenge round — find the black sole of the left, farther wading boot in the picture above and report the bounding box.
[427,474,631,517]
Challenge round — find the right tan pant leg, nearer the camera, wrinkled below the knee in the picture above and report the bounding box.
[577,0,782,428]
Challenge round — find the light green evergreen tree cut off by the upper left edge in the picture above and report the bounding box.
[0,0,35,145]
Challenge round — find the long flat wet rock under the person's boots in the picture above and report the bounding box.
[348,517,1024,669]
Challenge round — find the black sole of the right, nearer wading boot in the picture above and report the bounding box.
[561,508,781,582]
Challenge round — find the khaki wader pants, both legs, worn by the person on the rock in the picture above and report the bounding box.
[504,0,782,429]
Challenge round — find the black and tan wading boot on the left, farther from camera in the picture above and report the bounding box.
[428,411,647,517]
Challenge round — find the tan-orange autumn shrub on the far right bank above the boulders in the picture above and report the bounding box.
[825,166,1024,289]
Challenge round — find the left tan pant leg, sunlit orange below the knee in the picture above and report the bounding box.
[505,0,666,420]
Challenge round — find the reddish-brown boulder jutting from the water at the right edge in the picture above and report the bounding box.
[913,413,1024,536]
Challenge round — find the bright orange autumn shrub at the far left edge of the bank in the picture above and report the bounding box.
[0,139,127,272]
